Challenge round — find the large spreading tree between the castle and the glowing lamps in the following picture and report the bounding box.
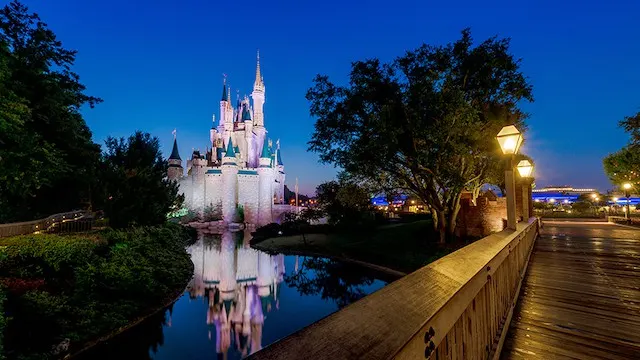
[307,29,533,242]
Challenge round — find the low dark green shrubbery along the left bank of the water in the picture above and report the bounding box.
[0,224,192,358]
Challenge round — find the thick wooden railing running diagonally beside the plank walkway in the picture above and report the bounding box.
[251,218,539,359]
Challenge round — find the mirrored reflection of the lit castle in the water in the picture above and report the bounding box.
[187,230,285,358]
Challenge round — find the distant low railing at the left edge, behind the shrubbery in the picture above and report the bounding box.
[0,210,100,237]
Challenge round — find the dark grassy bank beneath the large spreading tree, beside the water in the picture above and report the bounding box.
[256,220,458,273]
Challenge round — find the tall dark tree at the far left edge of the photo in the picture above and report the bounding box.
[0,1,101,221]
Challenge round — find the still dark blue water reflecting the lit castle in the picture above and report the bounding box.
[83,231,386,360]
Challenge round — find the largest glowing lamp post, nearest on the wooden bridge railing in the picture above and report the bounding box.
[496,125,523,230]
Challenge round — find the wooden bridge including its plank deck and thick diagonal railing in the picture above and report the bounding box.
[251,218,640,359]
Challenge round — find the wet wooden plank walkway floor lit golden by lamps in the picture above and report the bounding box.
[501,221,640,359]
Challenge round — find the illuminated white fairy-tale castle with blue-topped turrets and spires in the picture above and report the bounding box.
[167,54,285,225]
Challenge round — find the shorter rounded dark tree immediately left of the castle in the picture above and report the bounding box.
[100,131,184,228]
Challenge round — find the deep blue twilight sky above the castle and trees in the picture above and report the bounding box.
[25,0,640,193]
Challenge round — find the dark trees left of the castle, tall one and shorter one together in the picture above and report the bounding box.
[0,1,177,226]
